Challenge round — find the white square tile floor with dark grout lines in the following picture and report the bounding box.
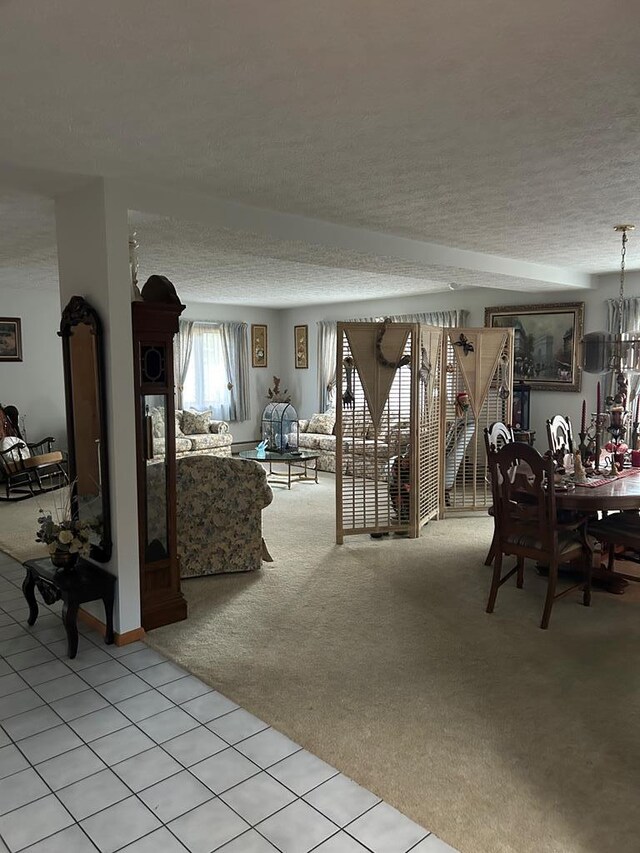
[0,553,455,853]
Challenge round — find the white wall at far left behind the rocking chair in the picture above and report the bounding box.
[0,281,67,450]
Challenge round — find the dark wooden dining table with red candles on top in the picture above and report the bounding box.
[556,468,640,594]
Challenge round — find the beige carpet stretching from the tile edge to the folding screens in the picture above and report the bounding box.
[0,475,640,853]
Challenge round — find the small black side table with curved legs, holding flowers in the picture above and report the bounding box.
[22,557,116,658]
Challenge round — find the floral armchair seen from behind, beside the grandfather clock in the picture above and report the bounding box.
[176,456,273,578]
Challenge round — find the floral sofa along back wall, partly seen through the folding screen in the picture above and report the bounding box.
[298,411,409,480]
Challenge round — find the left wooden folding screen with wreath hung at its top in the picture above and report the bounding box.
[336,323,443,544]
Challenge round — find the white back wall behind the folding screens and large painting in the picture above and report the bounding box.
[281,272,640,450]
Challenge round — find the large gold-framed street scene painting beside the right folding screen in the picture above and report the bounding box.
[484,302,584,391]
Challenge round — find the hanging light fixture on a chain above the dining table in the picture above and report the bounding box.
[582,225,640,408]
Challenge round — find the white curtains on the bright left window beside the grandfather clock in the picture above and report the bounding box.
[182,322,248,421]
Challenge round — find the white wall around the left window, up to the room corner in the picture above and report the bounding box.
[176,302,280,443]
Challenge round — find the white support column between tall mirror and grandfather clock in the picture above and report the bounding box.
[55,178,140,634]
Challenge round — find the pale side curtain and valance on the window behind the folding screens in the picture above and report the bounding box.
[318,309,469,412]
